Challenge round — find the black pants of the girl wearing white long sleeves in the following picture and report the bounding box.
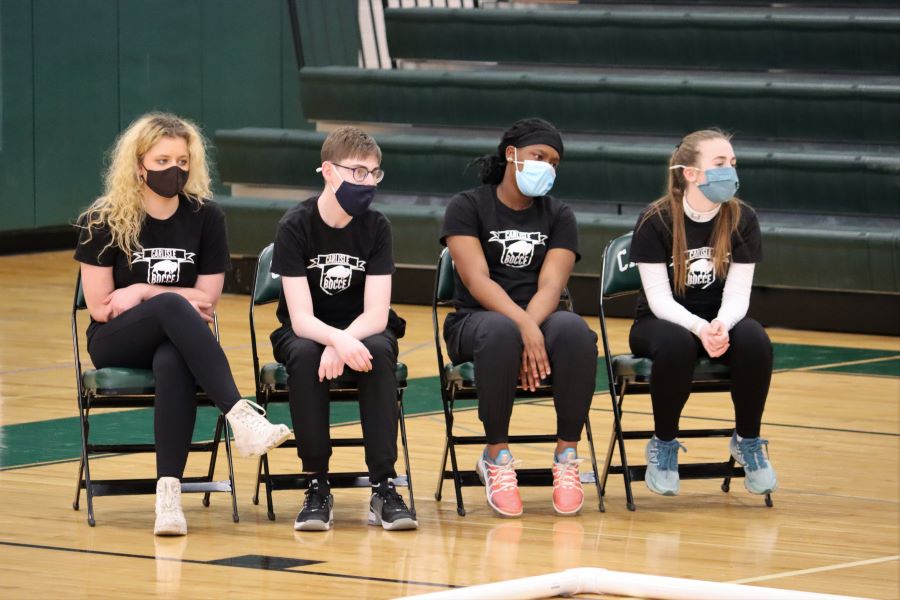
[629,316,772,441]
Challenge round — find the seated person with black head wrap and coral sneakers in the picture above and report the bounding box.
[441,118,597,516]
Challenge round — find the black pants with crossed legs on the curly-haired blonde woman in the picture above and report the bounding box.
[88,293,241,479]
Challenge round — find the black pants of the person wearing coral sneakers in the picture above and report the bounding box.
[444,310,597,444]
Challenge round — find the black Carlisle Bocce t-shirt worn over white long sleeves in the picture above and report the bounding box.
[630,205,762,321]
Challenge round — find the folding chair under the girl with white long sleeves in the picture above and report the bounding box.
[600,233,772,511]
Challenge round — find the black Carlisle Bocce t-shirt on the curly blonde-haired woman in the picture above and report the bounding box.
[75,196,231,289]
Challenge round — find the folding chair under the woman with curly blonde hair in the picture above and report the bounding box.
[72,273,239,527]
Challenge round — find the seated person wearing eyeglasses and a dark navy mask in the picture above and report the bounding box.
[271,127,418,531]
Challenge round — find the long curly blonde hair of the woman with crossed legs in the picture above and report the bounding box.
[78,112,212,265]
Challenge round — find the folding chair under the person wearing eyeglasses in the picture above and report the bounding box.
[250,244,416,521]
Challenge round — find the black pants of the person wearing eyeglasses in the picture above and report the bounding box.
[272,327,398,483]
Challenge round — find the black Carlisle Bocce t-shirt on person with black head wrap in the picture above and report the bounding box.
[441,185,581,309]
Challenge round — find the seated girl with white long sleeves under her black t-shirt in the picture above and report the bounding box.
[629,129,778,496]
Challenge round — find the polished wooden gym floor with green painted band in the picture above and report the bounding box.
[0,252,900,598]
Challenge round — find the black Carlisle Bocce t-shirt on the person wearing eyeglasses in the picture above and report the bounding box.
[272,197,394,329]
